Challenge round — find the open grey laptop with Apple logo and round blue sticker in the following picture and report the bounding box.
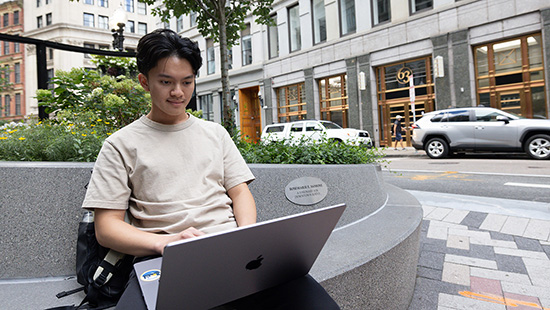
[134,204,346,310]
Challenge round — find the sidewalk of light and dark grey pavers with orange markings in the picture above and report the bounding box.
[409,193,550,310]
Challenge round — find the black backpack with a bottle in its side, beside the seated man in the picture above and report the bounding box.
[47,211,134,310]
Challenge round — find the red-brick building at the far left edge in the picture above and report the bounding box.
[0,0,27,121]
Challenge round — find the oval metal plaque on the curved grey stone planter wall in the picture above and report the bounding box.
[285,177,328,206]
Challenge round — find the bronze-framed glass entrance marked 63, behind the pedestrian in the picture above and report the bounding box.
[375,56,435,146]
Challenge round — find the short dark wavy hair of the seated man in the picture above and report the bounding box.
[136,29,202,76]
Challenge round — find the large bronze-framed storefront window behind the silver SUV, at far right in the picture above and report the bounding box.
[474,34,548,118]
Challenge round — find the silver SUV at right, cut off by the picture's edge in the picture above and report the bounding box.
[412,107,550,159]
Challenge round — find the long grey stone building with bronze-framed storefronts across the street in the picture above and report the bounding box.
[178,0,550,145]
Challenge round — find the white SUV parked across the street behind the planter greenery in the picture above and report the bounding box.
[260,120,373,147]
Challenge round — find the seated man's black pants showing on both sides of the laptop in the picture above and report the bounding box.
[116,271,340,310]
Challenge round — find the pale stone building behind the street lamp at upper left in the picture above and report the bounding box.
[24,0,159,115]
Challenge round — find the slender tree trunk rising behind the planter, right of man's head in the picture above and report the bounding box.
[219,7,237,137]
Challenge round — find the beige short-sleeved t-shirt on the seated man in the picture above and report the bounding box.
[82,115,254,234]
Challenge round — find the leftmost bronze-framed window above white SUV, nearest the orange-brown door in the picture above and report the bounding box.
[276,83,307,123]
